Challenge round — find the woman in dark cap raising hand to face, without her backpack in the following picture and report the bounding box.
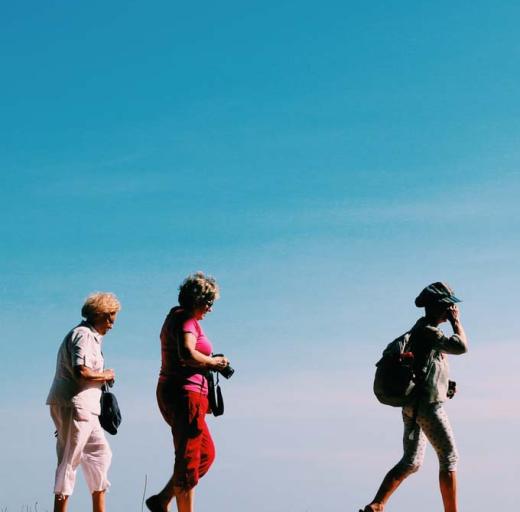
[360,282,468,512]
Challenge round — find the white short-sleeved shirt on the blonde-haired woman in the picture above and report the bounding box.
[47,321,104,415]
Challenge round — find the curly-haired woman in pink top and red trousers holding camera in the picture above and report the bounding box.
[146,272,229,512]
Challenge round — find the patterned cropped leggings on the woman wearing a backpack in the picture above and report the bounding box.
[396,402,459,473]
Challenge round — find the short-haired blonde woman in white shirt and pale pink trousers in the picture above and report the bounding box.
[47,293,121,512]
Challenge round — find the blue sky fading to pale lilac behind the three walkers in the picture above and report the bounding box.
[0,1,520,512]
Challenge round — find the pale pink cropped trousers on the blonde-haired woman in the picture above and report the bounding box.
[50,405,112,496]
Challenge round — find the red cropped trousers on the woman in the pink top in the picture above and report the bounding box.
[157,382,215,490]
